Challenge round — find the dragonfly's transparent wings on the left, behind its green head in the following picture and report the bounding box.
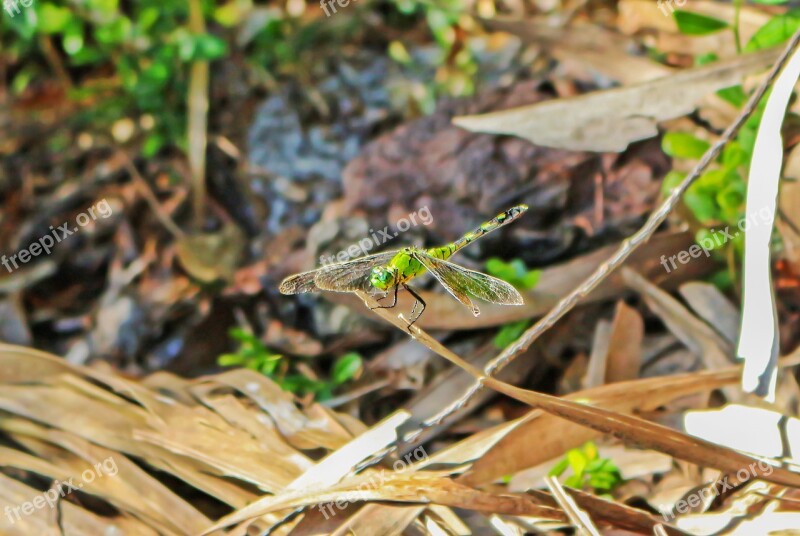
[280,251,397,294]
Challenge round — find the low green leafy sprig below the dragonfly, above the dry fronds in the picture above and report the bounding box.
[217,328,363,400]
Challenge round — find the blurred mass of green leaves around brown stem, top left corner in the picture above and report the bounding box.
[0,0,228,156]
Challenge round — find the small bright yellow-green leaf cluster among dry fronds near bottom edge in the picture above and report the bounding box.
[549,441,622,493]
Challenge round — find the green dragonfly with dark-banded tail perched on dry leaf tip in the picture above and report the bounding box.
[280,205,528,327]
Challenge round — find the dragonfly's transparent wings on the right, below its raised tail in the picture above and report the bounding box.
[413,251,523,316]
